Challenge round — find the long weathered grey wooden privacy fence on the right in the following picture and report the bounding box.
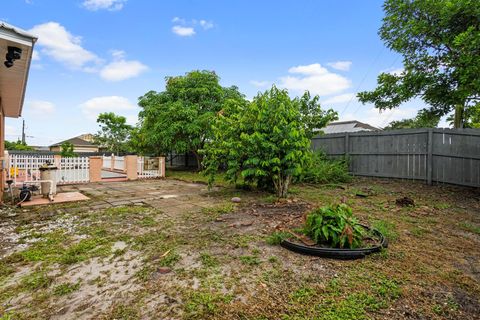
[312,129,480,187]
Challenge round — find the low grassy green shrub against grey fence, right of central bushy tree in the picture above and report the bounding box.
[297,151,352,183]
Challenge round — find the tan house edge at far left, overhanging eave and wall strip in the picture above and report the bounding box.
[0,21,37,202]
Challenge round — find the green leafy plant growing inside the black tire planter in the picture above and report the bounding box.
[304,203,364,249]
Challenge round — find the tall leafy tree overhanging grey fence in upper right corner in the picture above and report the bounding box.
[358,0,480,127]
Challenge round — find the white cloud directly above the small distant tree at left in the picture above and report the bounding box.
[80,96,137,121]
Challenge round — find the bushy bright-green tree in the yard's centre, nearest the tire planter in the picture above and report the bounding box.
[204,87,333,197]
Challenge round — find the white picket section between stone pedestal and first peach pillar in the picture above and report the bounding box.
[57,157,90,184]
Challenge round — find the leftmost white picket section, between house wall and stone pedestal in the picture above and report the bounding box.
[7,154,54,185]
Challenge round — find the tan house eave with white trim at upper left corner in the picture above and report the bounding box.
[0,21,37,118]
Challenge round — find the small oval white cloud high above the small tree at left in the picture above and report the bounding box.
[100,50,148,81]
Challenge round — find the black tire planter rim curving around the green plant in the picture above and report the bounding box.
[280,225,388,260]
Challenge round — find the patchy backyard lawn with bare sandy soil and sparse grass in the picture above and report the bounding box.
[0,176,480,320]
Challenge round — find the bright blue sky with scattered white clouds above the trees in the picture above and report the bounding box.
[0,0,428,145]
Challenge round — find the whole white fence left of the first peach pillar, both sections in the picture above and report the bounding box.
[7,154,90,185]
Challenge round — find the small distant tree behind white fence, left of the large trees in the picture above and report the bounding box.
[95,112,133,155]
